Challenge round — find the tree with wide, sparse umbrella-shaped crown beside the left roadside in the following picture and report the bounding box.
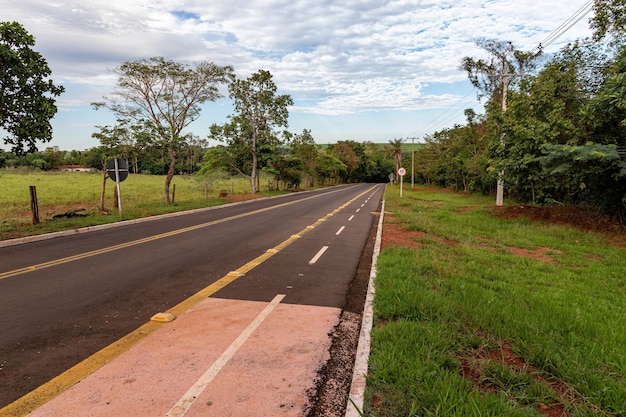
[94,57,233,204]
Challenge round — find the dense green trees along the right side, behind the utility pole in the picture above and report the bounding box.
[416,0,626,219]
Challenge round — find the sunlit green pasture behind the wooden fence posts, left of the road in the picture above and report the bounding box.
[0,171,276,240]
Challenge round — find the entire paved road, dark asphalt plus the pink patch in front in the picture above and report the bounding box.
[0,184,383,416]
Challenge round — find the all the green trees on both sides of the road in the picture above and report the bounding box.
[0,0,626,216]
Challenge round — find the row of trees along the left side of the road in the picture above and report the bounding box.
[0,22,393,204]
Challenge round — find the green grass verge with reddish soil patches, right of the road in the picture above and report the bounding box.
[363,187,626,417]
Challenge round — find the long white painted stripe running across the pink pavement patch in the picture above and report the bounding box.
[165,294,285,417]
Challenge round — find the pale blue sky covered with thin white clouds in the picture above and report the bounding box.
[0,0,591,150]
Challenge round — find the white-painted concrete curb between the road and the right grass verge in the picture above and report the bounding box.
[345,199,385,417]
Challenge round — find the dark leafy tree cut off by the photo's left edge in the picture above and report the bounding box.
[0,22,64,155]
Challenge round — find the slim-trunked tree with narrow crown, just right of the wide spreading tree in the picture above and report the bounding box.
[228,70,293,194]
